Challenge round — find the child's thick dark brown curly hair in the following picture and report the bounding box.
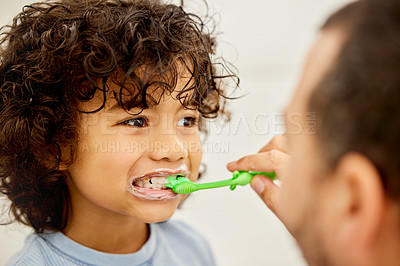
[0,0,238,232]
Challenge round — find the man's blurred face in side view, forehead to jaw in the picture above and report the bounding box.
[280,30,343,265]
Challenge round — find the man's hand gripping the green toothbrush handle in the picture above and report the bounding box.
[227,136,290,220]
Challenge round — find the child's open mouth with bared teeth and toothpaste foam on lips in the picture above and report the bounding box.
[128,169,186,200]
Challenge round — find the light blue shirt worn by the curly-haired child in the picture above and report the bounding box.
[6,221,215,266]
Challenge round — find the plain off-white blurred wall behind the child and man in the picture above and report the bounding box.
[0,0,349,266]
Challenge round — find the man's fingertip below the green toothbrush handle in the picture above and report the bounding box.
[251,176,280,218]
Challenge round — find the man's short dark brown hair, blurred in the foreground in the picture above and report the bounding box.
[309,0,400,200]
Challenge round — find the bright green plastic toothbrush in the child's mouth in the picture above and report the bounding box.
[165,171,276,194]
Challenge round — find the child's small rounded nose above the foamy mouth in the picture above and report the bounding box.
[149,134,188,161]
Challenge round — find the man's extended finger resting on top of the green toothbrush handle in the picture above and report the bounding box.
[227,150,289,175]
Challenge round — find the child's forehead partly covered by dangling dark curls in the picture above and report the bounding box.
[77,61,196,111]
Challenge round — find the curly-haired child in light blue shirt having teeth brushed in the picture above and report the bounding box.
[0,0,234,265]
